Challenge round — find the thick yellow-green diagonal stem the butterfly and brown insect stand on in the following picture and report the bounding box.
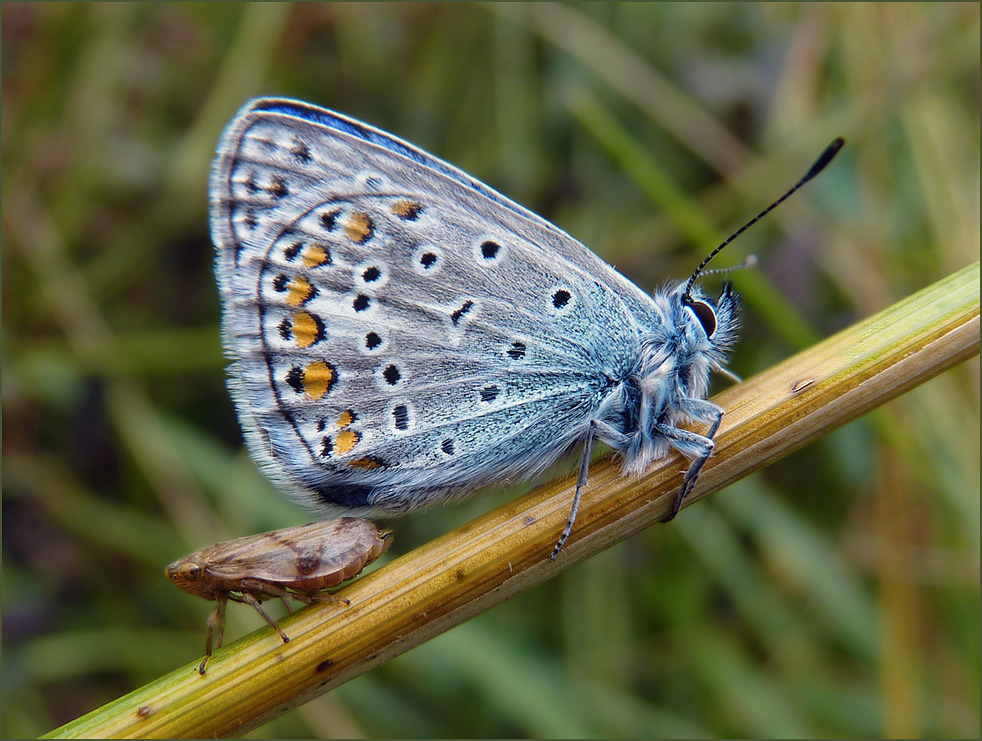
[48,262,979,738]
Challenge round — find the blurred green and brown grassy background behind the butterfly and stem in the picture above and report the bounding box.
[2,3,980,738]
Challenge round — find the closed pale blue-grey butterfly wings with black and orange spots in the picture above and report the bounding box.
[211,99,658,514]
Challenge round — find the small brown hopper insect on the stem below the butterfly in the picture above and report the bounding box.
[167,517,392,675]
